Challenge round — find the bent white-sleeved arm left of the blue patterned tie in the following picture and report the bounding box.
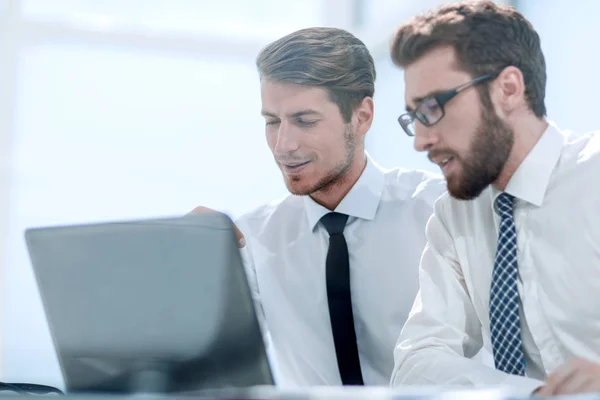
[391,198,541,393]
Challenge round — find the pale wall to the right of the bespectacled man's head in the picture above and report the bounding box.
[517,0,600,132]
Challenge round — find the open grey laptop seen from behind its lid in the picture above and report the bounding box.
[25,213,274,393]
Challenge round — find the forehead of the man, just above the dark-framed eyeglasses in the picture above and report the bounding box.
[404,46,471,107]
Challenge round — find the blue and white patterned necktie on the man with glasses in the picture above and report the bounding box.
[490,193,525,375]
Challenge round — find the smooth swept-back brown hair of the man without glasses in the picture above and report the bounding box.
[256,28,375,123]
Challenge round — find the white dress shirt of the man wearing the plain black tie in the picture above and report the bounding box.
[236,155,446,387]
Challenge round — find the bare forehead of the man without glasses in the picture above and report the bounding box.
[260,79,335,113]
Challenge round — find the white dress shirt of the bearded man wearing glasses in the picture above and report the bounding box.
[392,123,600,393]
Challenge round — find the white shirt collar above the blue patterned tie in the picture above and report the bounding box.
[492,121,566,207]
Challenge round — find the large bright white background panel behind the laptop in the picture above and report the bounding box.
[4,44,285,388]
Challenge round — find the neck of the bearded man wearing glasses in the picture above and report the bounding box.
[493,117,548,191]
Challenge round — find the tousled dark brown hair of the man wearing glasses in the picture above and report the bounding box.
[391,1,546,118]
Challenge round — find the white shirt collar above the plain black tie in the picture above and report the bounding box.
[303,154,385,230]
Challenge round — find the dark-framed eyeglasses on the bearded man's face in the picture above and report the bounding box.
[398,71,500,136]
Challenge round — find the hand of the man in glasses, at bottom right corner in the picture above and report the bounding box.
[535,358,600,396]
